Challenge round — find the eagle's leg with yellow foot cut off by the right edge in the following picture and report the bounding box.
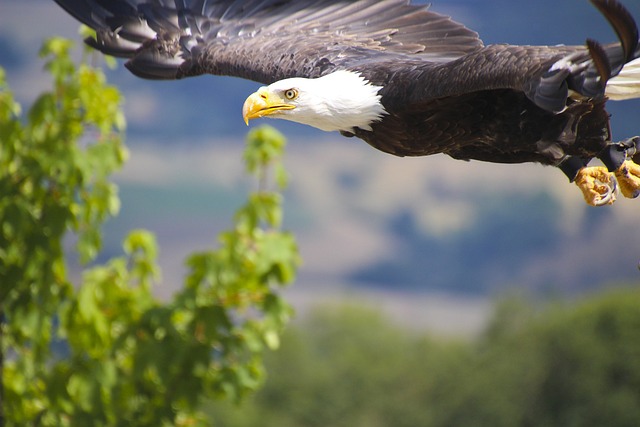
[600,136,640,199]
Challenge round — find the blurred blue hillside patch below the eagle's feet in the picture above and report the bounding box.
[349,191,640,294]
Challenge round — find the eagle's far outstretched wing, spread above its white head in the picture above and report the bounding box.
[55,0,482,83]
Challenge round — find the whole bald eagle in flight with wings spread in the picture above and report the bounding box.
[55,0,640,205]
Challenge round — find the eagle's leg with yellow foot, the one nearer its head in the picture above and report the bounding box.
[558,156,617,206]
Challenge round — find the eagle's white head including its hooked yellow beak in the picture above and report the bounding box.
[242,70,386,132]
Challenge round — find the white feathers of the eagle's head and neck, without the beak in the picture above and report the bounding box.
[281,70,386,132]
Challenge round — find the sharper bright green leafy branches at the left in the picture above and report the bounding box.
[0,39,299,427]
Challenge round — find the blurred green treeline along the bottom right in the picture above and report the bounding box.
[207,289,640,427]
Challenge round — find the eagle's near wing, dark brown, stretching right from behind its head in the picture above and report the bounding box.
[360,0,640,117]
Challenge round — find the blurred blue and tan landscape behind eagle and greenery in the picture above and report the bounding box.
[0,0,640,335]
